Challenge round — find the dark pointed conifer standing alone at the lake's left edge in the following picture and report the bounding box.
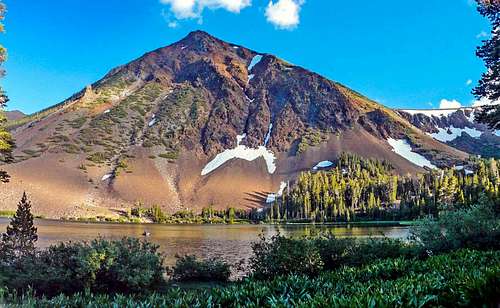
[0,193,38,262]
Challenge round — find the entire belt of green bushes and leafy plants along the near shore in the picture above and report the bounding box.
[0,194,500,307]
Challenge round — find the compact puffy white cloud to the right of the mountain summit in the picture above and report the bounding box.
[265,0,304,29]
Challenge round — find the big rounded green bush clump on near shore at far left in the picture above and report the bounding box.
[0,238,168,296]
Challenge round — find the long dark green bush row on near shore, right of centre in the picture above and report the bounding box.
[250,235,423,279]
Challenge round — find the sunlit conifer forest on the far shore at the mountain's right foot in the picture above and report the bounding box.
[276,154,500,222]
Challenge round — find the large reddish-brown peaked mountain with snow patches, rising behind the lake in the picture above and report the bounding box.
[0,31,468,218]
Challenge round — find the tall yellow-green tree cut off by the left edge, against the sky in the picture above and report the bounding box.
[0,0,14,183]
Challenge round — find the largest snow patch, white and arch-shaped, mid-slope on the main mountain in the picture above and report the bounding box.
[201,134,276,175]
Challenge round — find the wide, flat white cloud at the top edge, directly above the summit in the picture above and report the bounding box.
[160,0,252,19]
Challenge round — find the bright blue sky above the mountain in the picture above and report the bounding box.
[0,0,489,113]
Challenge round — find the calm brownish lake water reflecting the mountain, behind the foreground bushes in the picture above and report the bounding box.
[0,218,409,272]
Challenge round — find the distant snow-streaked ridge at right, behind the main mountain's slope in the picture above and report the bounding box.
[398,107,500,158]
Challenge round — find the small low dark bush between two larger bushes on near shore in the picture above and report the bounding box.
[170,256,231,282]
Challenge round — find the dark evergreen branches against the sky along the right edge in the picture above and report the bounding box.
[473,0,500,129]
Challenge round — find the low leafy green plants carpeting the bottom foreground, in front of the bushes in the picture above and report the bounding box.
[5,250,500,307]
